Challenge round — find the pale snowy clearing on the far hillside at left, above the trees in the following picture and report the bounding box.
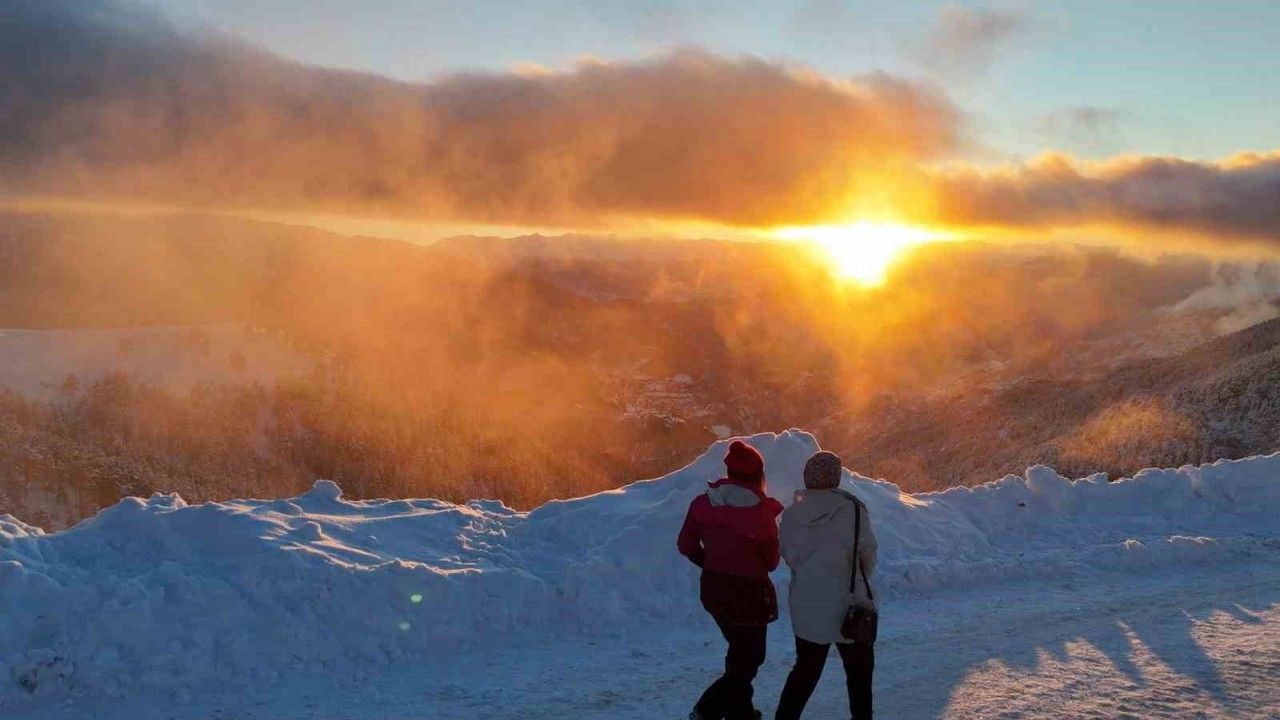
[0,324,315,400]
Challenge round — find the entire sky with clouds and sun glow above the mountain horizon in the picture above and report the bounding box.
[0,0,1280,261]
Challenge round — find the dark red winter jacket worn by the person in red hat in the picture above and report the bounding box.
[676,478,782,624]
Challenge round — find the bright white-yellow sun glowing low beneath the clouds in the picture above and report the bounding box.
[774,220,947,286]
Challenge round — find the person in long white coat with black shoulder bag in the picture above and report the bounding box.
[774,451,876,720]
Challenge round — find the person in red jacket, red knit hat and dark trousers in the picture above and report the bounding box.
[676,441,782,720]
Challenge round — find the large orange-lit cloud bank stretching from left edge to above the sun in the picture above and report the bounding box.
[0,0,957,225]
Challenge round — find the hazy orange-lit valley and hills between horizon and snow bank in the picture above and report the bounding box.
[0,207,1280,527]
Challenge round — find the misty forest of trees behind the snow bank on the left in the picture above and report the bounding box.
[0,363,707,528]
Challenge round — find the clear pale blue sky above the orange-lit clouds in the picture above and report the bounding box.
[152,0,1280,161]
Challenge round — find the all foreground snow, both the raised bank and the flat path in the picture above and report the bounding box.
[0,432,1280,720]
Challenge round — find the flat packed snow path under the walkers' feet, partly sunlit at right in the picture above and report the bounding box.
[399,562,1280,720]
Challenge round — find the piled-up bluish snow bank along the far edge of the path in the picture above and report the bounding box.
[0,430,1280,706]
